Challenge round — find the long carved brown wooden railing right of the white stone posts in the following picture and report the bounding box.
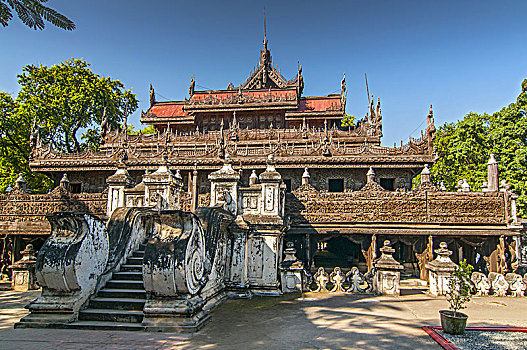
[286,186,509,225]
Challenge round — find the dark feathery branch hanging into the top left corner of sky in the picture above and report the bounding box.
[0,0,75,30]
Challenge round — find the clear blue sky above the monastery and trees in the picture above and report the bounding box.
[0,0,527,145]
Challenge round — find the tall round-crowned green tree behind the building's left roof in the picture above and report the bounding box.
[17,59,138,153]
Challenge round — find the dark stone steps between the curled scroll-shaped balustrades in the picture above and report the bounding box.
[67,244,146,331]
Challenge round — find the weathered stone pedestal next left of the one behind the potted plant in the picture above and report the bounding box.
[373,241,403,295]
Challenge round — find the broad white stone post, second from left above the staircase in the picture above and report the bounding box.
[143,164,183,210]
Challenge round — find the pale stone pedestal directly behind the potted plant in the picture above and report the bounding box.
[426,242,457,296]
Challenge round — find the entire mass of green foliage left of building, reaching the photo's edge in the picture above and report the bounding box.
[0,59,138,192]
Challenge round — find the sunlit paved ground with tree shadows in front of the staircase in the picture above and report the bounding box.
[0,291,527,350]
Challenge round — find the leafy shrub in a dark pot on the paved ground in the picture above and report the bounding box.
[439,260,473,334]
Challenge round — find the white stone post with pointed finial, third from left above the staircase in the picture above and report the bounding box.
[209,154,240,217]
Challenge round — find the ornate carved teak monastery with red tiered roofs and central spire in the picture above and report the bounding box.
[0,23,522,284]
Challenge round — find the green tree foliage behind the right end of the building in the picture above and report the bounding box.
[432,79,527,215]
